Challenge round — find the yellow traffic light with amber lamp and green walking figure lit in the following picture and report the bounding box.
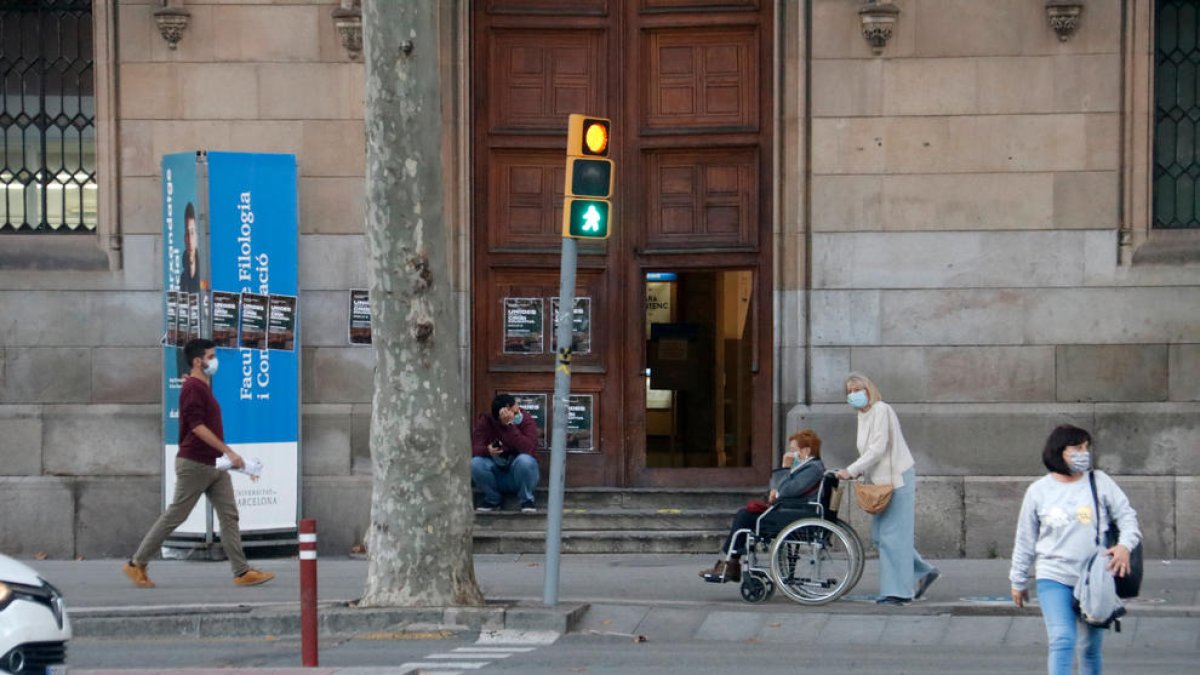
[563,114,613,239]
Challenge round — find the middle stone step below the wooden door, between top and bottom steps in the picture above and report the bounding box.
[475,508,736,533]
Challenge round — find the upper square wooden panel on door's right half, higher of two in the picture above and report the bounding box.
[642,26,761,133]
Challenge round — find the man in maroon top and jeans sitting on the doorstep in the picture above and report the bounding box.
[470,394,540,513]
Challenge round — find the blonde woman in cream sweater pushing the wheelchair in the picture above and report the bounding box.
[838,372,938,605]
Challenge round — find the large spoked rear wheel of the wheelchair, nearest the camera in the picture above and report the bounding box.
[770,518,863,605]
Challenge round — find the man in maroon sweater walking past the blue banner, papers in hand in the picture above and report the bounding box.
[121,338,275,589]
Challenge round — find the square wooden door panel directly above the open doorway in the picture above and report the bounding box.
[643,148,760,251]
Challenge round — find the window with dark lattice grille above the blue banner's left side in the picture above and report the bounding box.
[0,0,96,233]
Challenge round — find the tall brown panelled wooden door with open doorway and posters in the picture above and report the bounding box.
[472,0,773,485]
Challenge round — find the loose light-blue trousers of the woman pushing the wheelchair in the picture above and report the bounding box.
[871,468,934,598]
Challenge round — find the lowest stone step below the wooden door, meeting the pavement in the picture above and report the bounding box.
[474,530,727,554]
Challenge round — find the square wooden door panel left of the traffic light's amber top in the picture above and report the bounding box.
[487,29,608,133]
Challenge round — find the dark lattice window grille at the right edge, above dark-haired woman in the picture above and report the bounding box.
[1153,0,1200,229]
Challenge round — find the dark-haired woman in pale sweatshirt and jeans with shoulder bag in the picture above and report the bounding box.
[1008,424,1141,675]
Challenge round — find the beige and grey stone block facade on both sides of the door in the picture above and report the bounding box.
[0,0,1200,557]
